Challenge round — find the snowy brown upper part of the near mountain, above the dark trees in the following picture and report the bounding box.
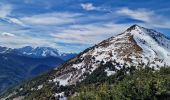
[49,25,170,85]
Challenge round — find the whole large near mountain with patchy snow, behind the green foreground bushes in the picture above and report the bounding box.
[1,25,170,100]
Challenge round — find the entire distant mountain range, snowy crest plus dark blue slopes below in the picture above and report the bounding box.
[0,46,76,94]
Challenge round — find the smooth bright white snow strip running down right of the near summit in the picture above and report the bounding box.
[131,27,170,66]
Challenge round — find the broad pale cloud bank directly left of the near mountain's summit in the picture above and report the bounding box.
[51,23,128,45]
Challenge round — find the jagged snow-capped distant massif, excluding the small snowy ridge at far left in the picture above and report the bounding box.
[15,46,76,60]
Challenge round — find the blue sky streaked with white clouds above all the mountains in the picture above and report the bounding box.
[0,0,170,52]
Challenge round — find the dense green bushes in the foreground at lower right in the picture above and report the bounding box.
[69,68,170,100]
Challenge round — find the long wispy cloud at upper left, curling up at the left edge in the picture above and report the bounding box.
[0,3,81,26]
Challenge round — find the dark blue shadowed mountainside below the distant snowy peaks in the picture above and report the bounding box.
[0,53,64,93]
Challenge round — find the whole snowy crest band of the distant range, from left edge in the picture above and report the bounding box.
[0,46,77,60]
